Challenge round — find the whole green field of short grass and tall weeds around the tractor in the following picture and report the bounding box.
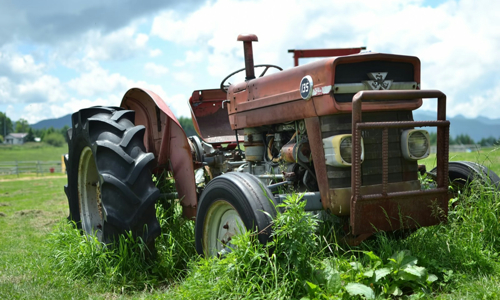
[0,144,500,299]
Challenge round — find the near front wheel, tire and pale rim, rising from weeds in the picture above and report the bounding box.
[195,172,276,257]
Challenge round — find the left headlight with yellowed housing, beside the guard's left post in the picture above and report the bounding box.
[323,134,365,167]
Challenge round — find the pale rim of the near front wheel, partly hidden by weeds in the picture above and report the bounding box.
[203,200,246,256]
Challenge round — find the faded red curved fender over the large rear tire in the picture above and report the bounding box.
[120,88,198,218]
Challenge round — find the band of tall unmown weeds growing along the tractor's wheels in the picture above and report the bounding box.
[47,170,500,299]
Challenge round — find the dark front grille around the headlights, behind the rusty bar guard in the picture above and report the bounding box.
[320,111,418,189]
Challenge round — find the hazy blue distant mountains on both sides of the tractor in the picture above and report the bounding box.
[31,110,500,142]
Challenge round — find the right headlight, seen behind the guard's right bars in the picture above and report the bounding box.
[401,129,431,160]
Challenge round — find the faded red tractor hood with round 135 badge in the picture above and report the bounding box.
[227,53,422,129]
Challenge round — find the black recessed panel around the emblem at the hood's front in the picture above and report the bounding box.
[334,60,415,102]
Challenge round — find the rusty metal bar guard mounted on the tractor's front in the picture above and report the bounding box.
[350,90,450,235]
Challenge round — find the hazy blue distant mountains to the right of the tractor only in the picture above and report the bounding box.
[413,110,500,142]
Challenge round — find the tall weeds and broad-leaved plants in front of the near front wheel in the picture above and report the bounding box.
[167,196,437,299]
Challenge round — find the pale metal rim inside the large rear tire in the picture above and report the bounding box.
[78,147,103,241]
